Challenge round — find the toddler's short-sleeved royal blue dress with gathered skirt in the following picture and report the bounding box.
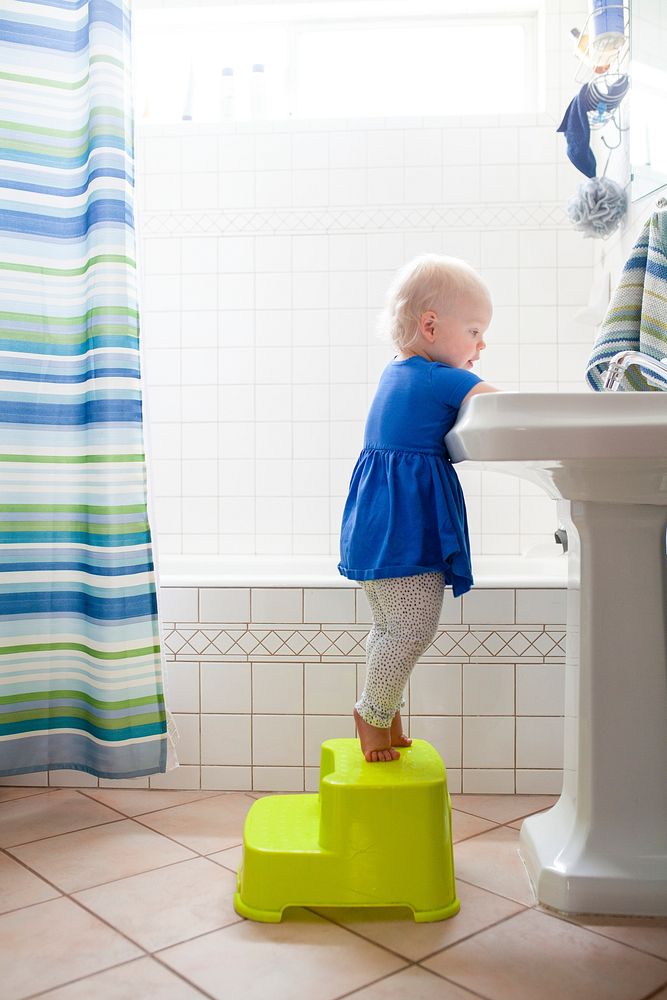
[338,355,481,597]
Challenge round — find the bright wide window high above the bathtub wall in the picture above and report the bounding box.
[134,0,537,122]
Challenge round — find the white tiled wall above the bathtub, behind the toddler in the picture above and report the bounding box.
[137,0,593,554]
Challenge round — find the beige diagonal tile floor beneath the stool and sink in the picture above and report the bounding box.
[0,787,667,1000]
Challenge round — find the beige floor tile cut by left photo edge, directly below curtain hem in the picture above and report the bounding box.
[0,788,121,847]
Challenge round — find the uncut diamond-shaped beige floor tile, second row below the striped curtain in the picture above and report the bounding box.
[9,819,193,892]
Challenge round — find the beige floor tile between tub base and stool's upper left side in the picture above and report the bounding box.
[136,792,253,854]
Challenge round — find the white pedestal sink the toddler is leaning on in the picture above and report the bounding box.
[446,392,667,915]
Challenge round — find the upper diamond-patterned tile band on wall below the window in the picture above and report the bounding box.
[141,202,570,238]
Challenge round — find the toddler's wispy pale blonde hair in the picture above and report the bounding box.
[378,253,491,350]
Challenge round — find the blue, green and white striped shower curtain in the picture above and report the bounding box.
[0,0,175,778]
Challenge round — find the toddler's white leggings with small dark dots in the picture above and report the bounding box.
[355,573,445,729]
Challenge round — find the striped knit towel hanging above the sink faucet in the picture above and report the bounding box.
[586,199,667,392]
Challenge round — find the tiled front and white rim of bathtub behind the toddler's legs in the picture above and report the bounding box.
[0,558,566,794]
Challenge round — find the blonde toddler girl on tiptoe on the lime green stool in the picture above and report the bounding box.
[338,254,497,761]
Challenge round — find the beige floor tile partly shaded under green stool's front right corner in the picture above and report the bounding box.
[317,882,523,962]
